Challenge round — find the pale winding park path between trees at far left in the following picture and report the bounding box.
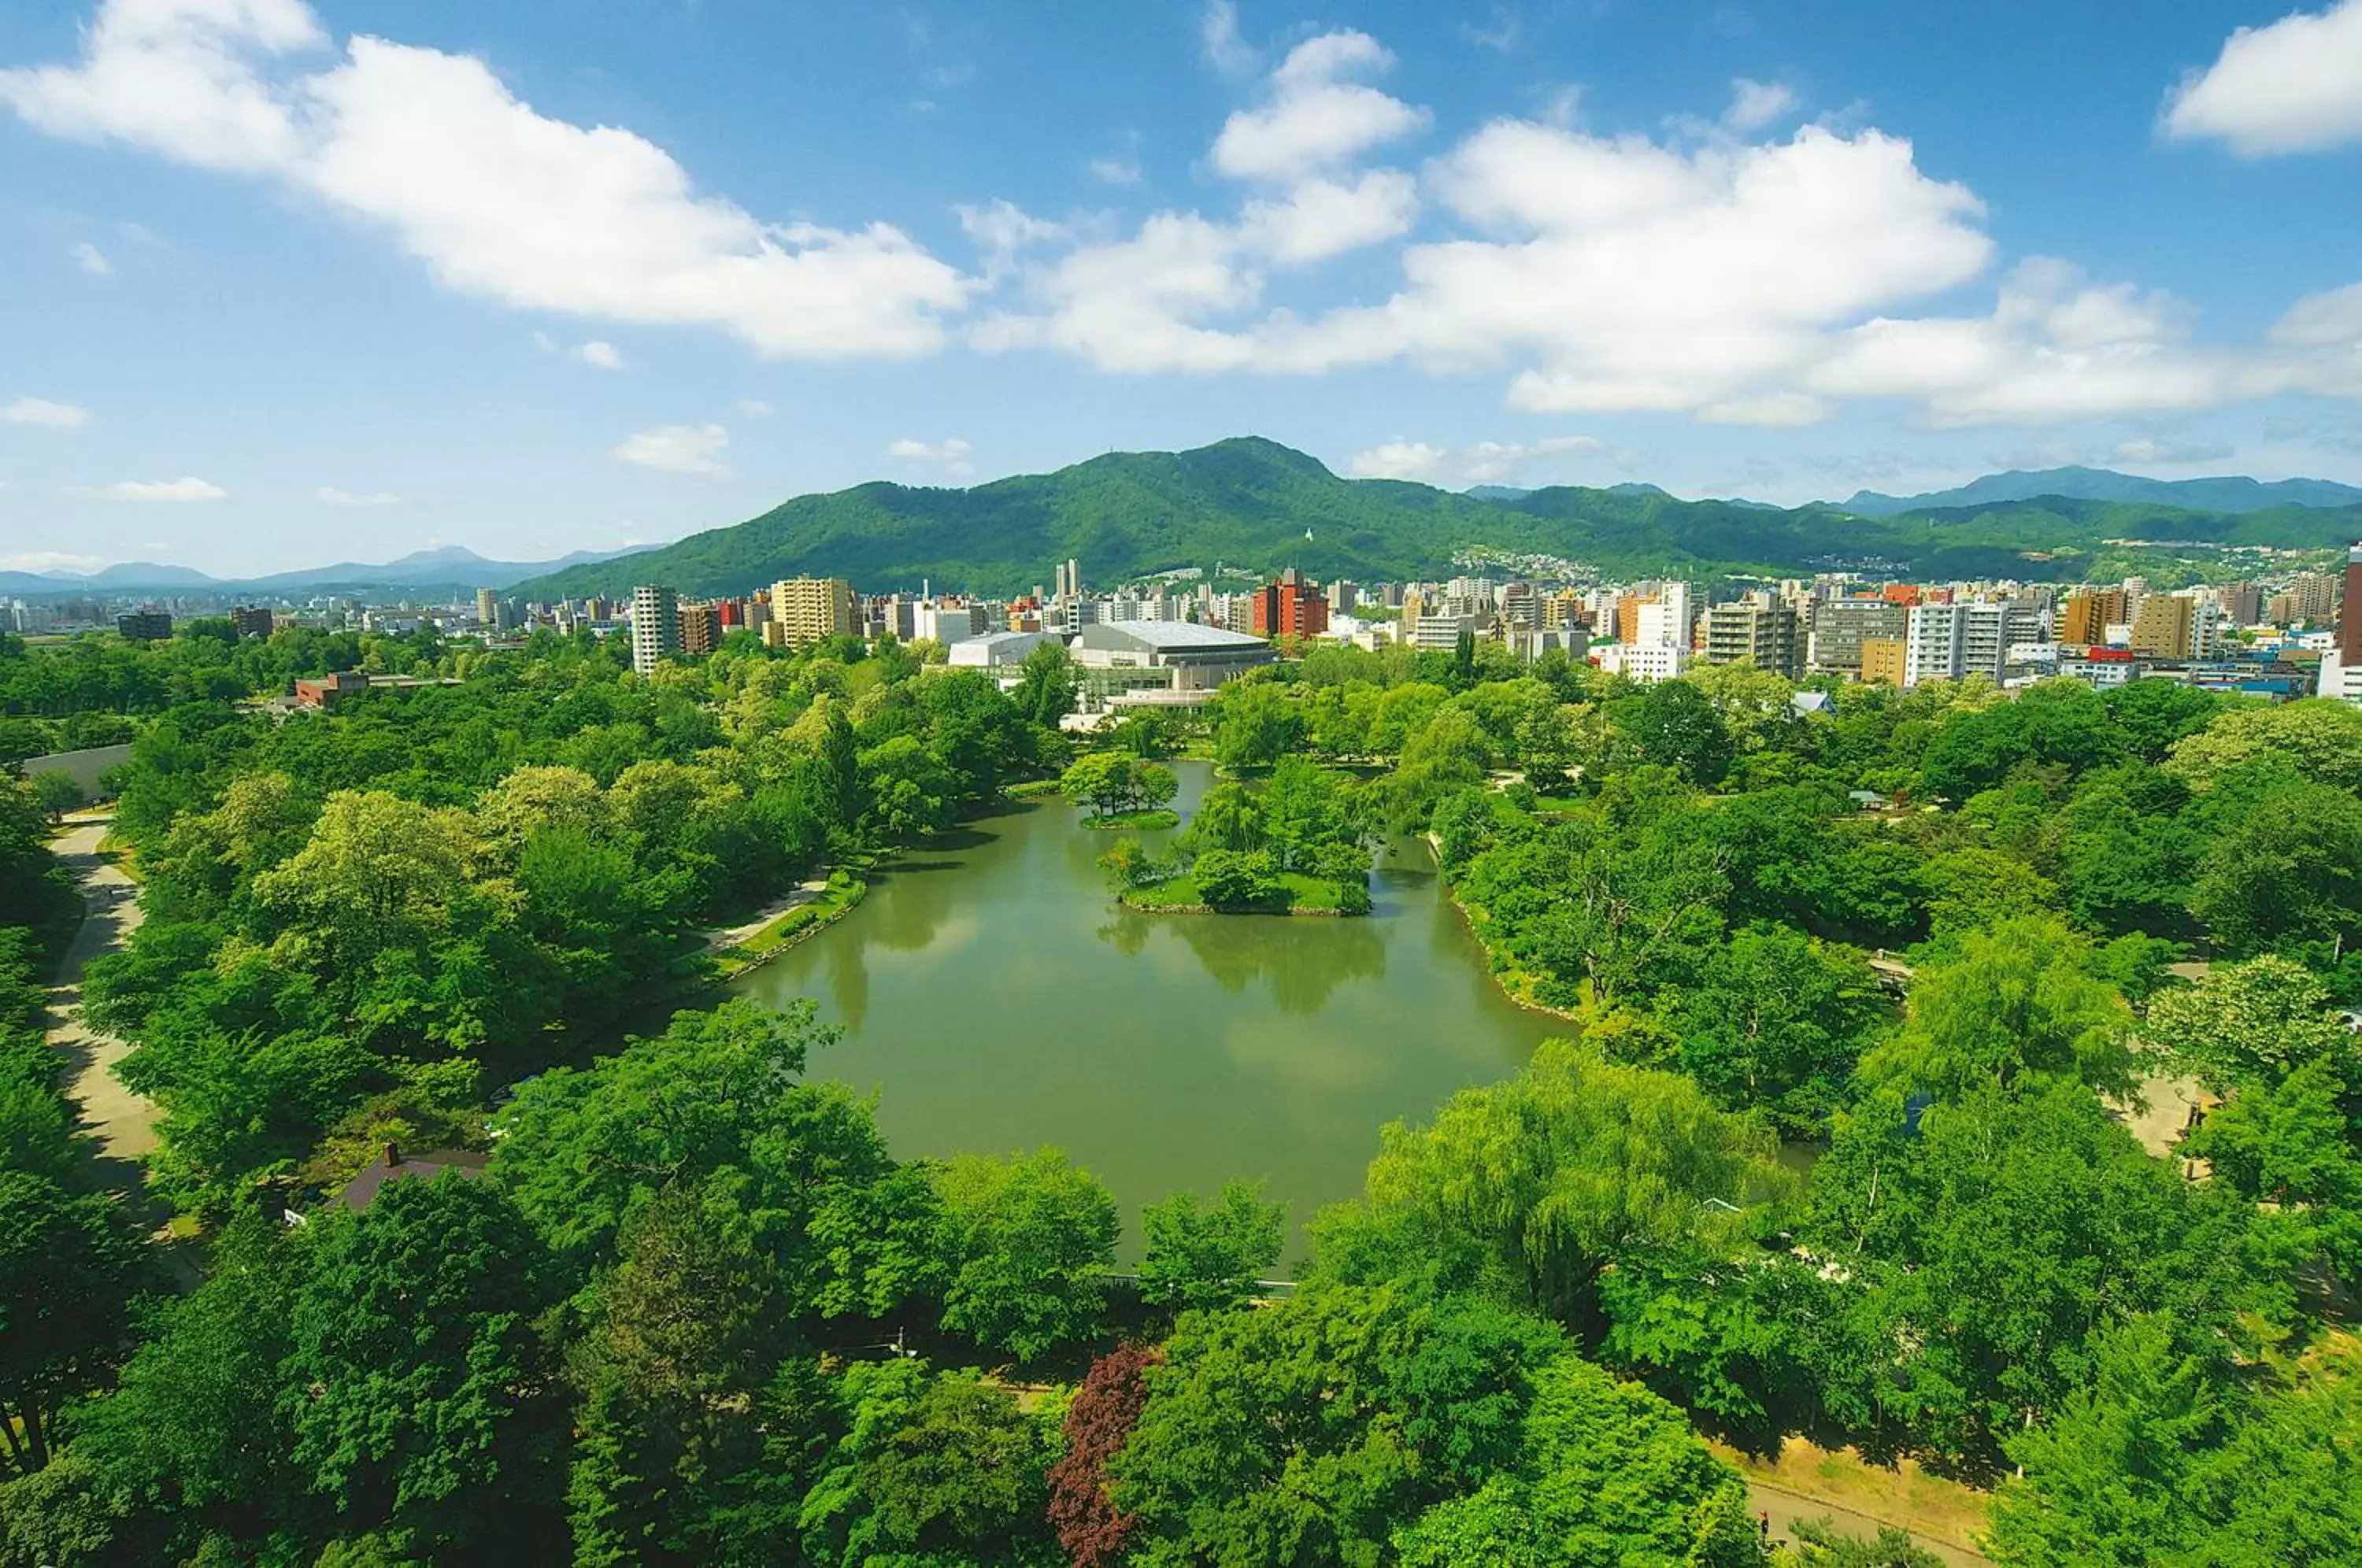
[50,817,156,1204]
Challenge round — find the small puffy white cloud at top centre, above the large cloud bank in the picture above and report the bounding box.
[1214,33,1429,179]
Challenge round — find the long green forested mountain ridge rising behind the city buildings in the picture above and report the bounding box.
[515,437,2362,600]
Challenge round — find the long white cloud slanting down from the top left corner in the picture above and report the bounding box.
[0,0,978,359]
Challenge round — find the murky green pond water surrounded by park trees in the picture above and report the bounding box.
[737,763,1564,1256]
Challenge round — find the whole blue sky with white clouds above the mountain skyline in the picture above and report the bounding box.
[0,0,2362,574]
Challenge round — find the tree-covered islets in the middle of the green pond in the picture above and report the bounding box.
[1082,751,1370,914]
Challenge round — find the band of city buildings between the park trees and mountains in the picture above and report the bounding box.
[18,543,2362,713]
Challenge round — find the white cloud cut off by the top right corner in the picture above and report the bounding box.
[2159,0,2362,158]
